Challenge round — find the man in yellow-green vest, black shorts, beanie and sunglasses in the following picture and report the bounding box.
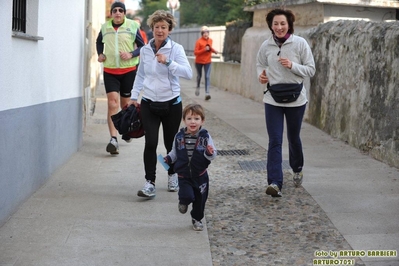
[96,2,145,154]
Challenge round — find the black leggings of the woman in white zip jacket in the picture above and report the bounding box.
[140,99,183,183]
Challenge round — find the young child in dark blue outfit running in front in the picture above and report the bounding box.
[164,104,217,231]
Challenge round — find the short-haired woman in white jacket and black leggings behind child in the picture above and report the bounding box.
[129,10,193,198]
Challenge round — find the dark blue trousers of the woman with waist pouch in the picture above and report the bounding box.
[265,103,306,190]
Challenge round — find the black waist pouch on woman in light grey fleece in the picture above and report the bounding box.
[265,83,303,103]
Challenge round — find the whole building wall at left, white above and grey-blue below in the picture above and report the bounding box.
[0,0,91,226]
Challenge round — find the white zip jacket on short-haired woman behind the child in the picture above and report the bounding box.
[130,39,193,102]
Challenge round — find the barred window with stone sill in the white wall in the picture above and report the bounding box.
[12,0,43,41]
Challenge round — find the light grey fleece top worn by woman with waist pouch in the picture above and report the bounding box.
[256,34,316,107]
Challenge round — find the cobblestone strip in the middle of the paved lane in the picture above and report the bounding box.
[185,95,364,266]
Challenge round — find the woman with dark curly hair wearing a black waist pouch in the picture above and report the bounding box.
[256,9,316,197]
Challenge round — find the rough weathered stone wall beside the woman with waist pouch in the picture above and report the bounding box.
[305,20,399,167]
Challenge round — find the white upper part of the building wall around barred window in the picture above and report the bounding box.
[0,0,85,111]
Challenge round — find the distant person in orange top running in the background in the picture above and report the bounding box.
[194,26,218,100]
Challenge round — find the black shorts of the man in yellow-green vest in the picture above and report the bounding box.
[104,70,137,98]
